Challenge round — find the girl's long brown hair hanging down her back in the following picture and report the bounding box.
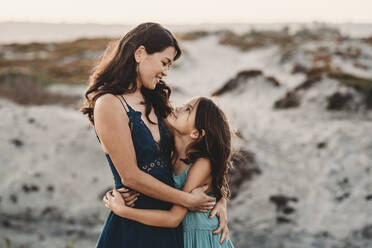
[186,97,233,199]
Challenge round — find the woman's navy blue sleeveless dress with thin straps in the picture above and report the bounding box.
[96,98,183,248]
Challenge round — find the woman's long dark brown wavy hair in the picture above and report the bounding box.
[80,23,181,125]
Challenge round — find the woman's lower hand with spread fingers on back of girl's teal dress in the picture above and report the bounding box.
[209,198,229,244]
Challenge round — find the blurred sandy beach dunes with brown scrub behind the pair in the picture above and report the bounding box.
[0,23,372,248]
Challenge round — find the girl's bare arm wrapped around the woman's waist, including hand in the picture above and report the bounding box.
[104,158,211,228]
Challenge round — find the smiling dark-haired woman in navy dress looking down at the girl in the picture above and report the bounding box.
[81,23,226,248]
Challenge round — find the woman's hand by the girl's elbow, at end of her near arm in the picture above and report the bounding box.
[189,185,216,212]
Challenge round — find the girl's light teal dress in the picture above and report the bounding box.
[173,166,234,248]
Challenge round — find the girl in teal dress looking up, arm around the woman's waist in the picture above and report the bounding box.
[104,97,233,248]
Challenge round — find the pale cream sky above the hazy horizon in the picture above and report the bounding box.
[0,0,372,24]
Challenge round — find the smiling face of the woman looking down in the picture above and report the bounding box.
[135,46,177,90]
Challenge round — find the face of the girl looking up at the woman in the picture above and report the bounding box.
[167,98,199,138]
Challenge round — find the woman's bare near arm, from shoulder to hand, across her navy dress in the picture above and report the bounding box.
[94,94,215,208]
